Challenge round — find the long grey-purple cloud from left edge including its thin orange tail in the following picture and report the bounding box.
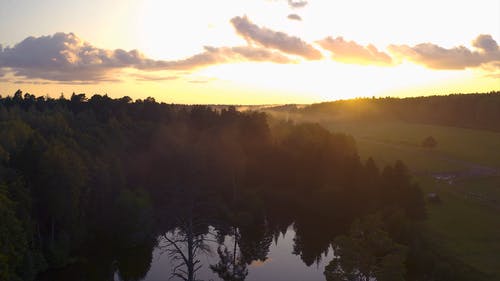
[0,33,294,83]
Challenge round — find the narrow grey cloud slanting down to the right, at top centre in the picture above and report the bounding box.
[231,16,322,60]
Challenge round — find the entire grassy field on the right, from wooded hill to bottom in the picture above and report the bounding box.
[323,122,500,280]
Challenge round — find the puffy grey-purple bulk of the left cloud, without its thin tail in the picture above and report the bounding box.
[0,33,152,81]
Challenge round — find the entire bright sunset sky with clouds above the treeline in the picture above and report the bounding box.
[0,0,500,104]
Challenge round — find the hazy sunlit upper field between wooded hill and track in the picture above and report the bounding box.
[323,122,500,171]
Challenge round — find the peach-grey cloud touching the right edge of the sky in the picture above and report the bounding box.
[389,34,500,69]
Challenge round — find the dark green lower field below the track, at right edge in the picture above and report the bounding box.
[418,177,500,280]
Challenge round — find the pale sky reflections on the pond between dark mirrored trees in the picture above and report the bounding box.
[137,224,333,281]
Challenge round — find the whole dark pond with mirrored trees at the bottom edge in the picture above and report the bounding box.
[38,190,345,281]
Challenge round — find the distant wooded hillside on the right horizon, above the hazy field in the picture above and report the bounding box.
[296,91,500,131]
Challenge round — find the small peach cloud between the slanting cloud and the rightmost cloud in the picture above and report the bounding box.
[317,37,392,65]
